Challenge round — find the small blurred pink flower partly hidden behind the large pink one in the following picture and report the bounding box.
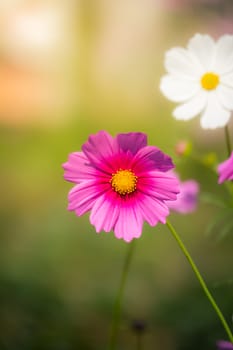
[167,172,199,214]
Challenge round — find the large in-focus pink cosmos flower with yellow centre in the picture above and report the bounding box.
[63,131,179,242]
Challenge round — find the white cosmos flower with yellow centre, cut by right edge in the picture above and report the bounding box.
[160,34,233,129]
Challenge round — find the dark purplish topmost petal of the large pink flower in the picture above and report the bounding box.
[116,132,147,154]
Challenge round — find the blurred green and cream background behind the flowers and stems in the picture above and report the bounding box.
[0,0,233,350]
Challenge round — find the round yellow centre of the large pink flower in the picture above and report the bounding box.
[110,169,137,195]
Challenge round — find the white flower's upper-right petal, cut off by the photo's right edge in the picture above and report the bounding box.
[214,35,233,74]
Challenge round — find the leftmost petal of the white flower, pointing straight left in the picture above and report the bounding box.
[160,75,200,102]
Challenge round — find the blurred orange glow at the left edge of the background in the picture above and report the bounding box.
[0,65,56,124]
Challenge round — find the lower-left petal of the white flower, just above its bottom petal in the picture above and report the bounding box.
[173,91,206,120]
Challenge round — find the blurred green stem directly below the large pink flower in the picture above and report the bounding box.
[109,239,135,350]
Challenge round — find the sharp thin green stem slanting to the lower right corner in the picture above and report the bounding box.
[166,221,233,343]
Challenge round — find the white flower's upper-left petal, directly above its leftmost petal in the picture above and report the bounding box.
[165,47,204,80]
